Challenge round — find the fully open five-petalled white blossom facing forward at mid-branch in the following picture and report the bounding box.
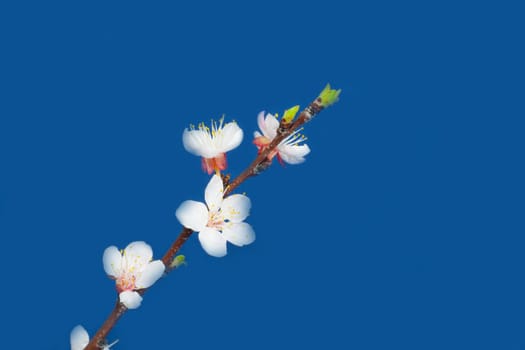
[175,175,255,258]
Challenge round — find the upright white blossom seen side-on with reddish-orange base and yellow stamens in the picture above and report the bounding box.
[182,117,243,174]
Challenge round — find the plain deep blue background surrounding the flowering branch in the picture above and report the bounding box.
[0,1,525,350]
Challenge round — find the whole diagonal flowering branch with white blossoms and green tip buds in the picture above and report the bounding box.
[77,85,341,350]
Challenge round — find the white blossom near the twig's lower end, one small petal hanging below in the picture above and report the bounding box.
[102,241,165,309]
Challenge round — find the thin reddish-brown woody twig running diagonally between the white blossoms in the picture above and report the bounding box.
[84,94,323,350]
